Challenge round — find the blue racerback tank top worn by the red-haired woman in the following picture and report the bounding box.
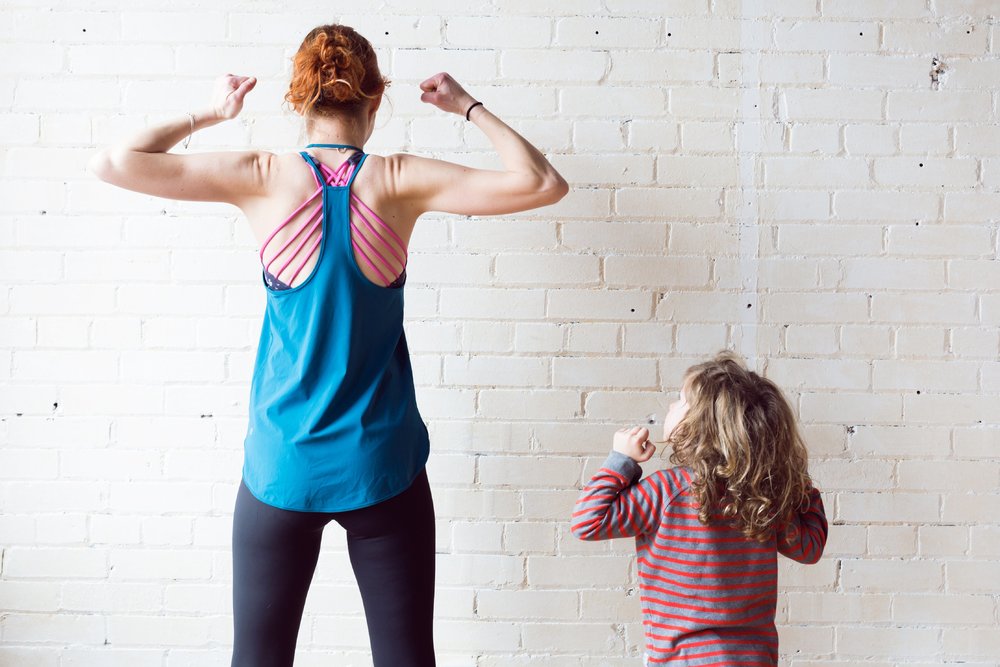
[243,145,430,512]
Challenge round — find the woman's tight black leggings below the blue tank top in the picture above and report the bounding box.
[232,472,435,667]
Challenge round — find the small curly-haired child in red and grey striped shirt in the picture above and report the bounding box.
[573,352,827,667]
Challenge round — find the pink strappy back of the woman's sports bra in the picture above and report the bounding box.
[260,149,407,290]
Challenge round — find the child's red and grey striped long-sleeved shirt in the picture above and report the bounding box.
[572,452,827,667]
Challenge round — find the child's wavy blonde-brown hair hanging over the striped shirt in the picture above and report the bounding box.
[667,351,812,542]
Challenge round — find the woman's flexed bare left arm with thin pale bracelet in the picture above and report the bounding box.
[87,74,274,206]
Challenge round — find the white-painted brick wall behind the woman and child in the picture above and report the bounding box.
[0,0,1000,667]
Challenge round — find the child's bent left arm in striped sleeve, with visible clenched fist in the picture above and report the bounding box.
[572,428,669,540]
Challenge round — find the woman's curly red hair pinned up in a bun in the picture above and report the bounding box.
[285,23,389,117]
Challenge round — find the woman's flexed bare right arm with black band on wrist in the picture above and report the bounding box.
[387,73,569,215]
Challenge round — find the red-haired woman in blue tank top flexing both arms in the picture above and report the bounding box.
[90,25,567,667]
